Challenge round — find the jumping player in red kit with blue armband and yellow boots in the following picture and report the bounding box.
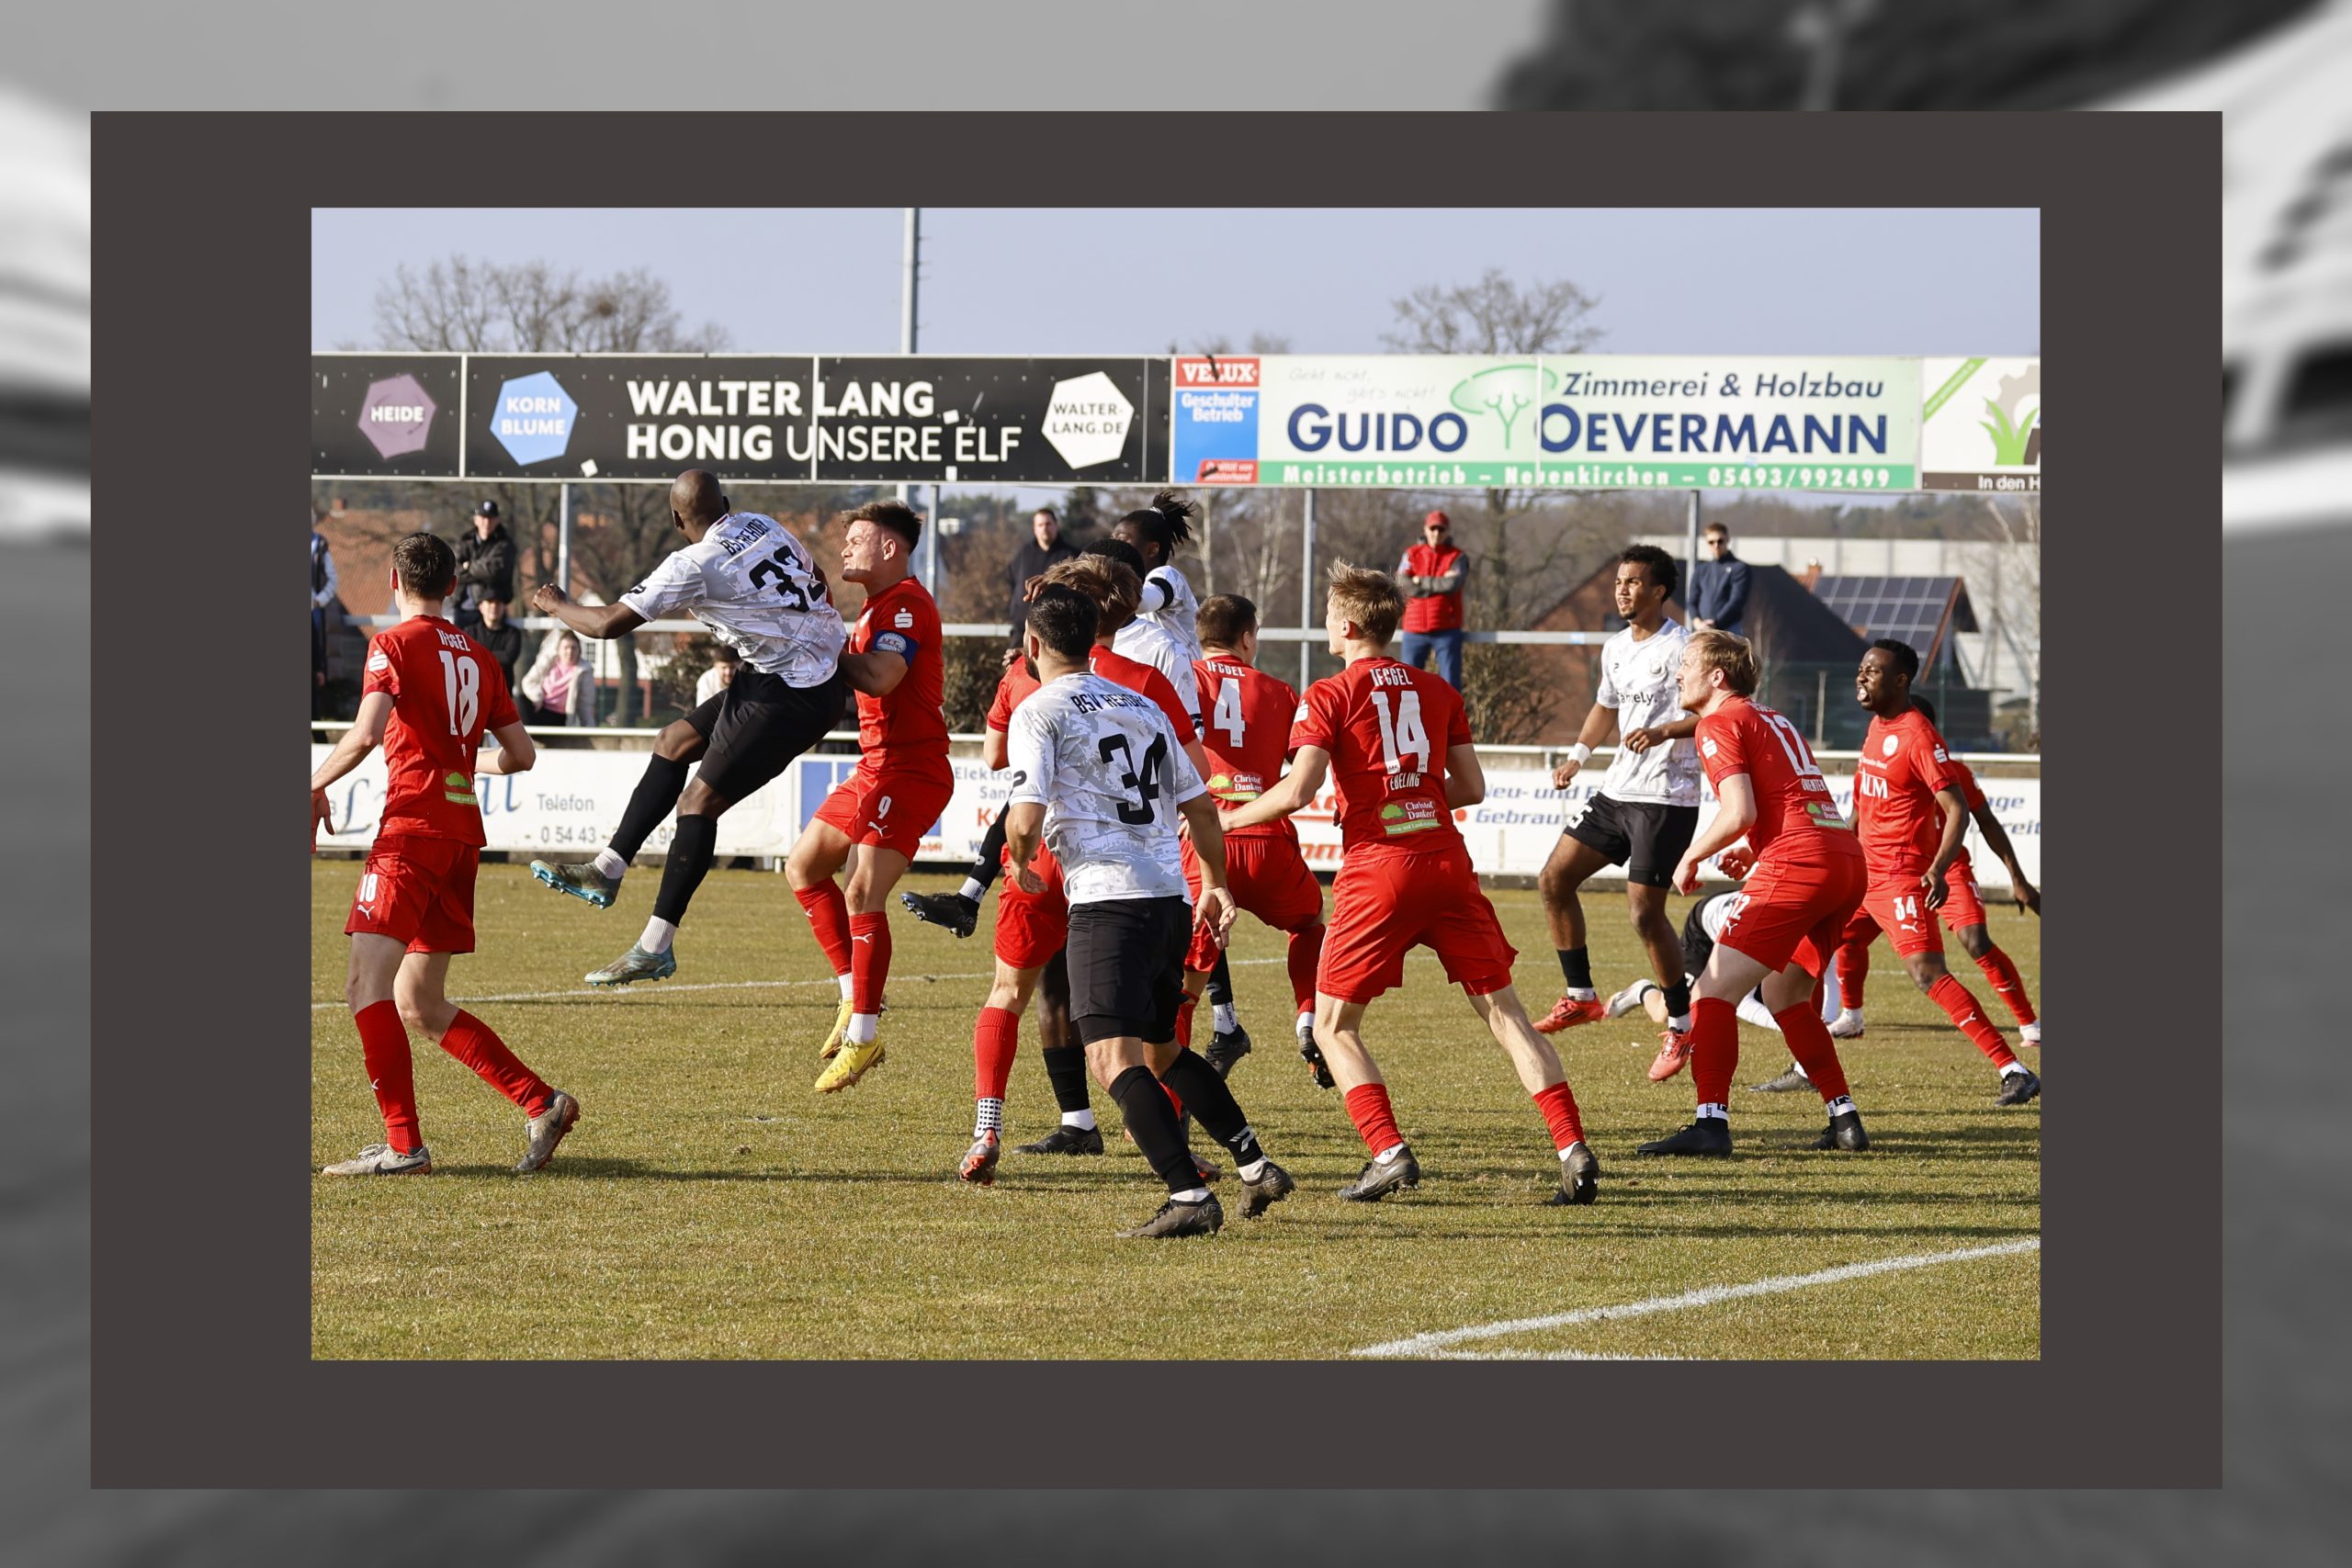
[783,501,955,1093]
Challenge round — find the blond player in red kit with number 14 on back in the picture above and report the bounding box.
[1223,564,1600,1203]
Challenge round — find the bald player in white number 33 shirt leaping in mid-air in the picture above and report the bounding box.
[532,468,849,985]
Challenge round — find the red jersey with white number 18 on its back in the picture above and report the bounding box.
[360,616,517,849]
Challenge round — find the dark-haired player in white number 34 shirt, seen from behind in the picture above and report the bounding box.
[1004,583,1296,1239]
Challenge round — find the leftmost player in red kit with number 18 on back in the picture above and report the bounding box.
[311,534,581,1176]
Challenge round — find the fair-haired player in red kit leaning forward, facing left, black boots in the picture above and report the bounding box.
[1637,630,1870,1155]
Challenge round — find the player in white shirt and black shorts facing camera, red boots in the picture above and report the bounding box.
[1536,546,1698,1077]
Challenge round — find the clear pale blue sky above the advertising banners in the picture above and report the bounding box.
[311,207,2041,355]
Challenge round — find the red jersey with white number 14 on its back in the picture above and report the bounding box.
[1291,659,1470,853]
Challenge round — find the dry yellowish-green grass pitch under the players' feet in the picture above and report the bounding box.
[311,861,2063,1359]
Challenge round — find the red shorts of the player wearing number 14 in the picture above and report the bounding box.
[1315,849,1520,1001]
